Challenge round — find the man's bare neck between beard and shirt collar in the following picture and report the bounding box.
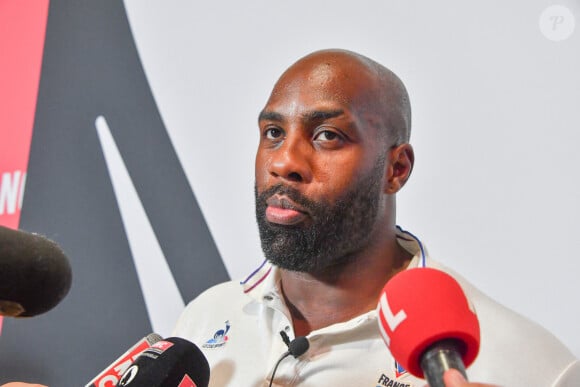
[281,238,412,336]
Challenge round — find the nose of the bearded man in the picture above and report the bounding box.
[269,137,312,183]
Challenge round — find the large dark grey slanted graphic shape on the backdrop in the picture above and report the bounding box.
[0,0,228,387]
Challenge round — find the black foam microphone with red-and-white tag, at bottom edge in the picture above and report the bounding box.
[117,337,209,387]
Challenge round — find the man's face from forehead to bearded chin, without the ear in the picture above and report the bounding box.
[255,56,385,273]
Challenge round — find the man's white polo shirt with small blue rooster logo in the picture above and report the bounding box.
[173,230,580,387]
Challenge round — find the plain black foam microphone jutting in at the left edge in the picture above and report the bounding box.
[0,226,72,317]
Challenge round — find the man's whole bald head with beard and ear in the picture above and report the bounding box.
[255,50,414,280]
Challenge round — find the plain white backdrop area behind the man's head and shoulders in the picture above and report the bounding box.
[125,0,580,356]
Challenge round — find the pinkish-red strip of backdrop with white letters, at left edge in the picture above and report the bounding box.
[0,0,49,331]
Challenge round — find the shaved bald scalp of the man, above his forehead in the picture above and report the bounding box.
[270,49,411,146]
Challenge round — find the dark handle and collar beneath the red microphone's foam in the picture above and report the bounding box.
[421,339,467,387]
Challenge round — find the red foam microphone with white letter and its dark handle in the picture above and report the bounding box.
[378,268,479,387]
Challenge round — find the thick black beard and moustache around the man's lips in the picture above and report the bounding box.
[254,159,385,274]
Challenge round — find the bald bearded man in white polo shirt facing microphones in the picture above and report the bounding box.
[174,50,580,387]
